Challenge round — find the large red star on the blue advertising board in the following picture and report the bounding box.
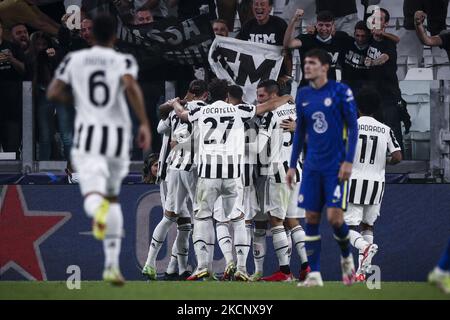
[0,186,71,280]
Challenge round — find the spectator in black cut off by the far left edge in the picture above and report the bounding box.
[0,20,25,157]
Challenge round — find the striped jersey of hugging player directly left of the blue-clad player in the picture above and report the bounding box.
[259,103,301,183]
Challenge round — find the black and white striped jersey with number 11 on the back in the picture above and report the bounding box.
[348,117,401,205]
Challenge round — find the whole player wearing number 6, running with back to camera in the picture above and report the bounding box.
[47,15,151,285]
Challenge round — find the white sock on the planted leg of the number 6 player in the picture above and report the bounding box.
[103,203,123,269]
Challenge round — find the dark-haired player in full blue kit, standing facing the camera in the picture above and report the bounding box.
[286,49,358,287]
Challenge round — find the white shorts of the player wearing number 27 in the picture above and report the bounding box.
[195,178,243,221]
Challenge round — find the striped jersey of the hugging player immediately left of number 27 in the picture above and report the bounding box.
[169,101,202,171]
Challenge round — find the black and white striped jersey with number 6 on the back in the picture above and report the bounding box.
[55,46,138,159]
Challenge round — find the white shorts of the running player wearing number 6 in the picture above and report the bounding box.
[71,152,130,197]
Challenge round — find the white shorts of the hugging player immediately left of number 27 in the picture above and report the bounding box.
[164,169,197,218]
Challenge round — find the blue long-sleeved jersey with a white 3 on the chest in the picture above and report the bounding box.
[290,80,358,171]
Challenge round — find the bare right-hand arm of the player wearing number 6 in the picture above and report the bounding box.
[122,74,152,150]
